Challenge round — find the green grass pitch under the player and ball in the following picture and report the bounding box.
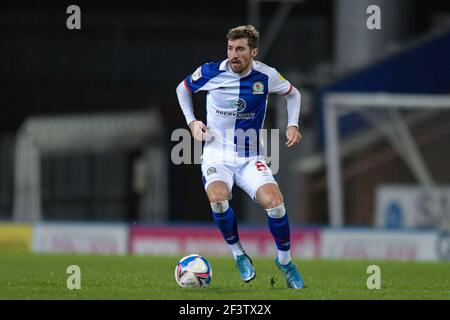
[0,252,450,300]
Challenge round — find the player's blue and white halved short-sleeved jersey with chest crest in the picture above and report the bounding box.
[184,60,292,161]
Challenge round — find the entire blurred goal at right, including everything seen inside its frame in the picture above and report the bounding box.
[324,93,450,229]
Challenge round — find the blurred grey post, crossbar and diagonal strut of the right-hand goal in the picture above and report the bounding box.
[324,92,450,227]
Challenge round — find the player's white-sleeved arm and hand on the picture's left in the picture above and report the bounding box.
[176,80,206,141]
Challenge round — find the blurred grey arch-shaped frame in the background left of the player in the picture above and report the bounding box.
[13,110,168,223]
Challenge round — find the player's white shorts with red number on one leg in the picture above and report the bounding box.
[202,157,277,200]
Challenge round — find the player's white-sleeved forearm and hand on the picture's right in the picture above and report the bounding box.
[285,85,302,148]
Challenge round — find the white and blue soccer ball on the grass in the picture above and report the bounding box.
[175,254,212,288]
